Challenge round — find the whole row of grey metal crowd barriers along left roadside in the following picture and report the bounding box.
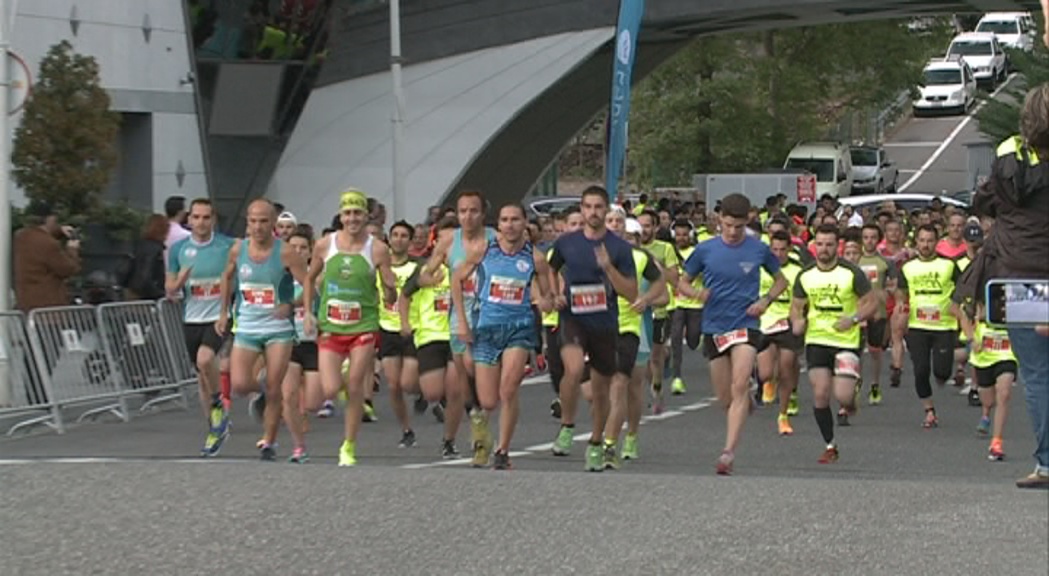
[0,300,196,435]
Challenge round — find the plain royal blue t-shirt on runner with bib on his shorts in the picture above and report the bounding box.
[684,236,779,334]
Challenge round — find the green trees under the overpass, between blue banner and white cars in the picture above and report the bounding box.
[627,20,951,186]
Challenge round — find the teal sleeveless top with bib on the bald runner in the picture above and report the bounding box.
[233,238,295,336]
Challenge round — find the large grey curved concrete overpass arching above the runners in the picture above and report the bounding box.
[266,0,1039,225]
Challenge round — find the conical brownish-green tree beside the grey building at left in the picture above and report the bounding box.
[12,41,120,217]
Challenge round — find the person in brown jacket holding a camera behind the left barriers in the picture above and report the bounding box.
[12,201,80,313]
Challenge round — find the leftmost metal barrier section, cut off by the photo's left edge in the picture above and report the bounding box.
[0,312,62,435]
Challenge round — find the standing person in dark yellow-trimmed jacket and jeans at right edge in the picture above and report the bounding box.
[956,84,1049,489]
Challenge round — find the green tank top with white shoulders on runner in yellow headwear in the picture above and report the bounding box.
[318,233,379,335]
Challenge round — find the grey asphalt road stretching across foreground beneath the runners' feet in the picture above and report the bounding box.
[0,348,1049,575]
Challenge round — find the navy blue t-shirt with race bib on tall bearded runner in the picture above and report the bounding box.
[550,230,637,329]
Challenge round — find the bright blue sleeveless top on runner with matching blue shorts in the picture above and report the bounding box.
[476,240,535,328]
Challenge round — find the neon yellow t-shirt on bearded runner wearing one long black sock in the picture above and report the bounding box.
[795,262,860,349]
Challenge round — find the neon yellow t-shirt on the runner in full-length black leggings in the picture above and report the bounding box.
[902,256,958,332]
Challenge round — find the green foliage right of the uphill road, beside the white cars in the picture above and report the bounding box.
[976,43,1049,144]
